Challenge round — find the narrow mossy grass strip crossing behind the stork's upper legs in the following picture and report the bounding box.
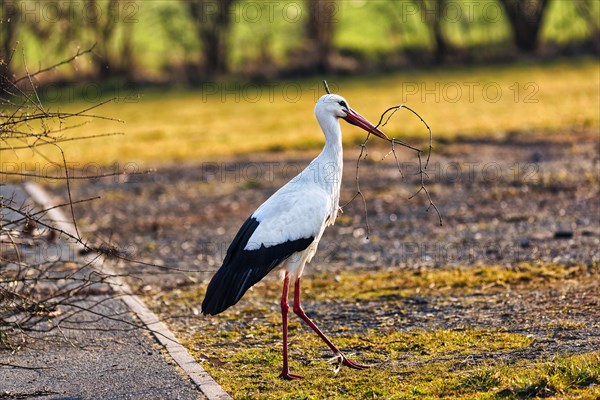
[200,262,597,301]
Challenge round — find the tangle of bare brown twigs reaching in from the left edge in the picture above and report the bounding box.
[0,47,155,350]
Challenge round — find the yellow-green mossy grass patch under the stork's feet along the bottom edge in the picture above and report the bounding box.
[178,320,600,399]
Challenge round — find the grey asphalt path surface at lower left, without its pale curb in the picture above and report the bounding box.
[0,185,205,399]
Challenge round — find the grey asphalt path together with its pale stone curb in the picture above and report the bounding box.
[0,184,229,399]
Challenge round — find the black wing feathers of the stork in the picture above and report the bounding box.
[202,217,315,315]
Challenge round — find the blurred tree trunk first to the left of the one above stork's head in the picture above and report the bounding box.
[183,0,236,76]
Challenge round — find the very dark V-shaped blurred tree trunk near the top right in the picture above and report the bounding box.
[500,0,549,52]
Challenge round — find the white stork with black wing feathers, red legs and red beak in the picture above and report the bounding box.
[202,94,388,379]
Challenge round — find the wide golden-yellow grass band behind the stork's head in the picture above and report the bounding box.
[2,59,600,169]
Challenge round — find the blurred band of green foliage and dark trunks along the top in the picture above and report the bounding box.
[0,0,600,86]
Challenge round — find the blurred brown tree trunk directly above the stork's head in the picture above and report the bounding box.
[306,0,338,72]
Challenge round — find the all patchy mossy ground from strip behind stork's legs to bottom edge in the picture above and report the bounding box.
[148,263,600,399]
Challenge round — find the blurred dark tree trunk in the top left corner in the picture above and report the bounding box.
[0,2,20,90]
